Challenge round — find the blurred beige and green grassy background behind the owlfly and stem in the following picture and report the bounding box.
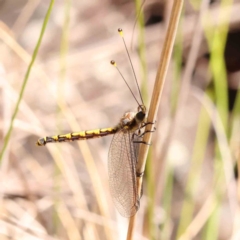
[0,0,240,240]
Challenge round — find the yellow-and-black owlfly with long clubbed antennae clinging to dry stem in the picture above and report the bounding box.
[37,29,153,217]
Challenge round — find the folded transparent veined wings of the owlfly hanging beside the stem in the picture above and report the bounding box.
[108,131,140,217]
